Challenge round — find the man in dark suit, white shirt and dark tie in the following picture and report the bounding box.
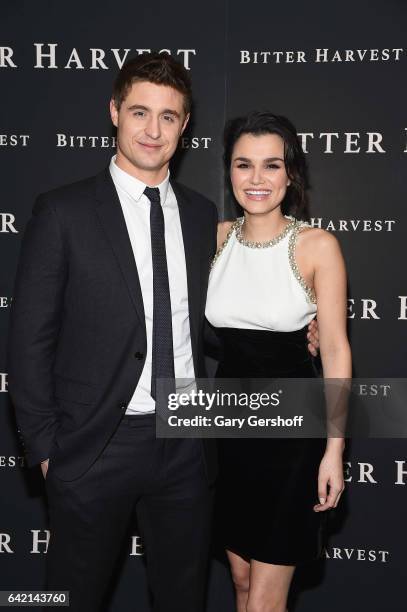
[9,54,217,612]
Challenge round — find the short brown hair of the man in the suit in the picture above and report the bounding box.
[112,53,192,115]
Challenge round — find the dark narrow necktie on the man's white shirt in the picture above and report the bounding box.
[144,187,175,399]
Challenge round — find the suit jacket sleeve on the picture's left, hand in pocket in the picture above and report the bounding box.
[8,196,67,466]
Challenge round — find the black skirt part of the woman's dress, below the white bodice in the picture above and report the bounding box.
[215,328,327,565]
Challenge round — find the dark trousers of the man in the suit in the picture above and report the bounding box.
[46,415,212,612]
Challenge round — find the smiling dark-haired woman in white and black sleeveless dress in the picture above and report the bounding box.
[206,112,351,612]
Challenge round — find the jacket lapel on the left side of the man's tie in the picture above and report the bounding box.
[96,169,145,326]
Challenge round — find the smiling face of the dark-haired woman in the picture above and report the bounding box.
[230,134,290,214]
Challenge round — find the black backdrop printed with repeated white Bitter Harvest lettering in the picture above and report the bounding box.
[0,0,407,612]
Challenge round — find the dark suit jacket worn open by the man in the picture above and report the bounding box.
[8,169,217,481]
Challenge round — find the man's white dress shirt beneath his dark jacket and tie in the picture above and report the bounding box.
[110,156,195,414]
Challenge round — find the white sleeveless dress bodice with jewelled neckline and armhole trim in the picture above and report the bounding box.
[205,217,317,332]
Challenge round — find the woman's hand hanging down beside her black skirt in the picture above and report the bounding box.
[314,449,345,512]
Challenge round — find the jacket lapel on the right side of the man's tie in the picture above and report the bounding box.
[171,181,201,352]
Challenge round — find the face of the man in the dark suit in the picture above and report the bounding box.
[110,81,189,186]
